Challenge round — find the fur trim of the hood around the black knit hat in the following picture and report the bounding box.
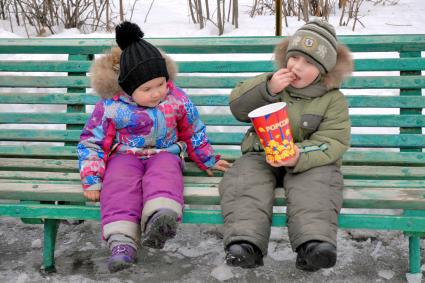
[90,47,177,99]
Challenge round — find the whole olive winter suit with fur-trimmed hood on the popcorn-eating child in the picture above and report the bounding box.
[219,37,352,255]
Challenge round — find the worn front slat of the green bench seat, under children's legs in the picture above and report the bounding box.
[0,183,425,209]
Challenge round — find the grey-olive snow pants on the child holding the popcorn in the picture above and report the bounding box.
[219,152,344,255]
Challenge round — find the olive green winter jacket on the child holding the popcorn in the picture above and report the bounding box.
[230,74,351,173]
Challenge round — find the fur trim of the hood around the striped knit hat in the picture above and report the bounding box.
[274,38,353,90]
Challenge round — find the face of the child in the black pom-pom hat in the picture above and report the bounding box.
[132,77,167,107]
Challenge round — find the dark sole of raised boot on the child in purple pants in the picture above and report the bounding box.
[142,214,177,249]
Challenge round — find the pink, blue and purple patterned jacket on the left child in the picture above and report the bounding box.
[77,48,219,190]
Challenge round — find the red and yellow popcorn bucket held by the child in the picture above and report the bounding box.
[248,102,295,162]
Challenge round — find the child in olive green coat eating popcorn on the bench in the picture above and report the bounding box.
[219,20,352,271]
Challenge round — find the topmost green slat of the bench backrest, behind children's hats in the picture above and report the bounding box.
[0,34,425,54]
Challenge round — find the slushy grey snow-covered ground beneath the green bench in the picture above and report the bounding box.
[0,218,425,283]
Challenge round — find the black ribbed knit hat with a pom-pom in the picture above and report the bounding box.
[115,22,169,95]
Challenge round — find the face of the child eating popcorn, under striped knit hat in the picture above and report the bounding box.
[287,56,320,88]
